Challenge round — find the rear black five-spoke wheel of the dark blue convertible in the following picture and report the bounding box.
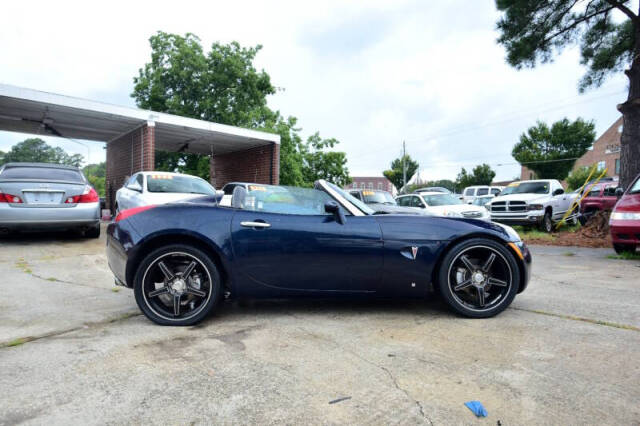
[134,244,220,325]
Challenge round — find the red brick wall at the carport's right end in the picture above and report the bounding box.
[210,143,280,189]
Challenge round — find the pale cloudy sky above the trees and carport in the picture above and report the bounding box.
[0,0,626,180]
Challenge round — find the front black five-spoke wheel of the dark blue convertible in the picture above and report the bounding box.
[438,238,520,318]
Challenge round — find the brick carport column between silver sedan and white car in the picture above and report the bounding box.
[105,121,156,213]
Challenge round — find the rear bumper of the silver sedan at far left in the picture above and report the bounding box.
[0,202,100,230]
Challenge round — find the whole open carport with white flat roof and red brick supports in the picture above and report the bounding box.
[0,84,280,210]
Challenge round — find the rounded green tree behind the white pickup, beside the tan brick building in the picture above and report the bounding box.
[511,118,596,180]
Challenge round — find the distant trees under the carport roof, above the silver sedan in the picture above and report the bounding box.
[0,138,84,167]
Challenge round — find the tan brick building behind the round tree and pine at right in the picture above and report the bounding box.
[520,117,622,180]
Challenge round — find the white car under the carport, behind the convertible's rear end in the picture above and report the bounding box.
[116,172,216,212]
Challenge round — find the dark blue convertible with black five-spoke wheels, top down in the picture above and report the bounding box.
[107,180,531,325]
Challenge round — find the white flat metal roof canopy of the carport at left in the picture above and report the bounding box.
[0,84,280,155]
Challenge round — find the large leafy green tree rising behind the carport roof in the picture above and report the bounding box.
[131,32,348,186]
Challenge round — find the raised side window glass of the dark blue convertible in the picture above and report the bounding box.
[242,185,333,215]
